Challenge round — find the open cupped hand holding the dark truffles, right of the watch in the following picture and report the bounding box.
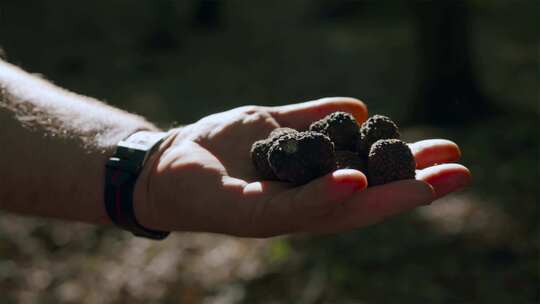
[135,98,470,237]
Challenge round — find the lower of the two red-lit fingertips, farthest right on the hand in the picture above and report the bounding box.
[416,164,472,199]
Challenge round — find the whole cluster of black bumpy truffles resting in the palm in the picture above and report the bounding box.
[251,112,416,186]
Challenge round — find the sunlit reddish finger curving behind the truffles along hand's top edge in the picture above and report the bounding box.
[270,97,368,130]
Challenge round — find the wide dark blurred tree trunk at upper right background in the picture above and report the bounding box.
[410,0,492,124]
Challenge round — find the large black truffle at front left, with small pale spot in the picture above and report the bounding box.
[268,131,335,185]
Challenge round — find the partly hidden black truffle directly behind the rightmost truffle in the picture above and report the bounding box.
[356,115,400,156]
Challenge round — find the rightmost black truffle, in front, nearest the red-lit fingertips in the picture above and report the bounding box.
[368,139,416,186]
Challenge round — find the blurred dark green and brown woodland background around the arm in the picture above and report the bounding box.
[0,0,540,304]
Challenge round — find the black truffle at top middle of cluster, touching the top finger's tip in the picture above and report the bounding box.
[309,112,359,151]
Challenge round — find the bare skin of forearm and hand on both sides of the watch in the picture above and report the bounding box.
[0,61,470,237]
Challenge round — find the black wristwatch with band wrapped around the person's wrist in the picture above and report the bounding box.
[105,131,170,240]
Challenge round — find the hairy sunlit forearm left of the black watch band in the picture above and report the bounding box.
[0,60,156,223]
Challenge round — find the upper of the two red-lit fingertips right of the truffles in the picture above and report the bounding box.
[409,139,461,169]
